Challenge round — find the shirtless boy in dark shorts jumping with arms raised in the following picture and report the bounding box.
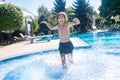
[41,12,80,68]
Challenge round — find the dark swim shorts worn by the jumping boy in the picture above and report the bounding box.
[59,41,74,54]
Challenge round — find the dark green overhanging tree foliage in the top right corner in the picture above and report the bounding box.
[99,0,120,19]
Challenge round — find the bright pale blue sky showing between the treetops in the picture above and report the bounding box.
[6,0,101,15]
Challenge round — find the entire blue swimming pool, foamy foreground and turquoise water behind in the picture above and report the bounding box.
[0,32,120,80]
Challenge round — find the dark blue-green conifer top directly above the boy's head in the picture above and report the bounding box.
[53,0,66,14]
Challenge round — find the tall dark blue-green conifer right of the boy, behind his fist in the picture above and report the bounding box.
[73,0,93,32]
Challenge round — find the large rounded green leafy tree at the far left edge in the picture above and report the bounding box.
[0,4,24,31]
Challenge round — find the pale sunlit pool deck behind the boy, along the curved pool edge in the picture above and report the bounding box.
[0,38,90,61]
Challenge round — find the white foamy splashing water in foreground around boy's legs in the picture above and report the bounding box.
[0,49,120,80]
